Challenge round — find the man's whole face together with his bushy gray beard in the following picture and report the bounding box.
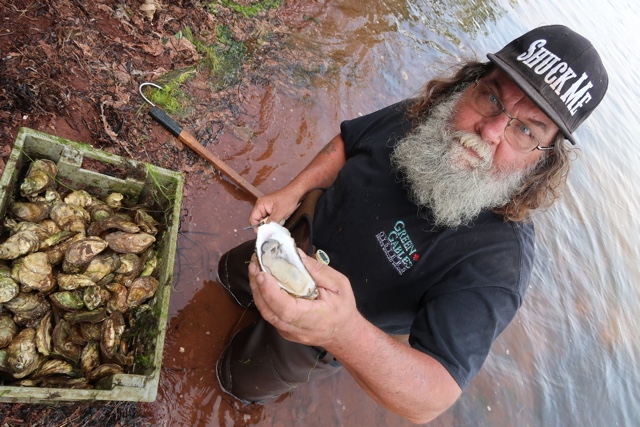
[384,72,557,231]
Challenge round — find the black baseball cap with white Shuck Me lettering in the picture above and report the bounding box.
[487,25,609,144]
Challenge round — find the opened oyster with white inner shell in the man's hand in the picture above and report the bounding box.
[256,222,318,299]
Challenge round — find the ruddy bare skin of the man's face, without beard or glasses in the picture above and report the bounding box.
[451,69,559,173]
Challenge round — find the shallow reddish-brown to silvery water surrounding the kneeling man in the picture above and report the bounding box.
[141,0,640,426]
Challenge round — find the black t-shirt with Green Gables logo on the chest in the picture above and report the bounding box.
[314,103,534,389]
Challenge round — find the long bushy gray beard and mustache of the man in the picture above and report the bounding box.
[391,94,535,228]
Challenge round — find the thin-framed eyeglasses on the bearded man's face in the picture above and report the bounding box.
[471,80,553,153]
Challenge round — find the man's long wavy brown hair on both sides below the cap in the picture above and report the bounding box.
[407,61,574,221]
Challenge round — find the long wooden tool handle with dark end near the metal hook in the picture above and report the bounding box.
[149,106,264,199]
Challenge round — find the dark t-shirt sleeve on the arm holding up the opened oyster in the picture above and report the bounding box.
[409,222,533,390]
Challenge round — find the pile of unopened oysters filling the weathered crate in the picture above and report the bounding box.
[0,160,159,388]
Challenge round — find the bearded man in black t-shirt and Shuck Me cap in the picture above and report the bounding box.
[217,26,608,423]
